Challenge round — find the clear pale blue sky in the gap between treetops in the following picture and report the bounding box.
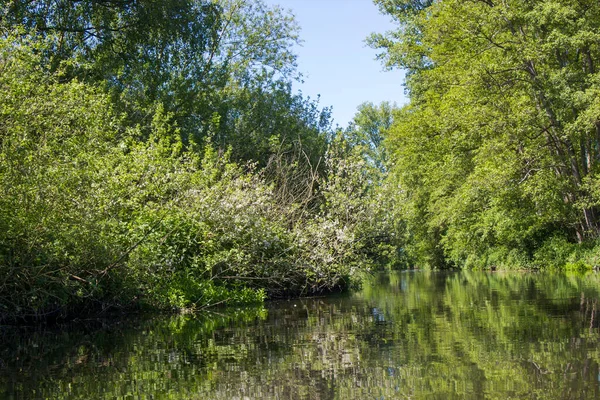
[265,0,406,127]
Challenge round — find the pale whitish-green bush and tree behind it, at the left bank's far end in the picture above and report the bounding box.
[310,103,407,269]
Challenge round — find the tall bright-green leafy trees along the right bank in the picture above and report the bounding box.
[369,0,600,269]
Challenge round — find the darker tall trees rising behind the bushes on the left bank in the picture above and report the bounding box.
[0,0,330,170]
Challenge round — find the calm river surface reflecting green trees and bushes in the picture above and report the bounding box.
[0,272,600,400]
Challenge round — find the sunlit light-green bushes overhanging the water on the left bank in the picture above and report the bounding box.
[0,37,351,318]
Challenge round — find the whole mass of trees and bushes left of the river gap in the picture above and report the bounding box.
[0,0,399,320]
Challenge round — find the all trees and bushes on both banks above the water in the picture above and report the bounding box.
[0,0,600,320]
